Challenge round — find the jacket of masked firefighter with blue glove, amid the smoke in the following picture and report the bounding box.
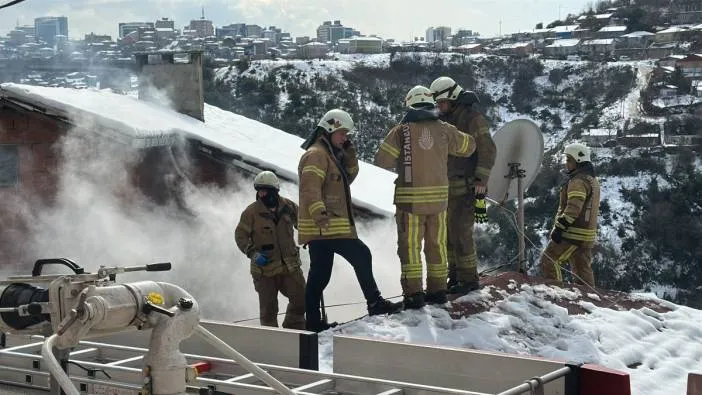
[234,197,300,276]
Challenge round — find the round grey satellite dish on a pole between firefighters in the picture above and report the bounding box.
[487,119,544,203]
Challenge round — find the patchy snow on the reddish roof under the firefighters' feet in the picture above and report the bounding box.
[319,284,702,395]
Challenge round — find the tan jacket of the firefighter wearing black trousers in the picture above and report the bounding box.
[297,133,358,244]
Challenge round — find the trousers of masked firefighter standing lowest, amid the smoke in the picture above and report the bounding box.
[252,267,305,330]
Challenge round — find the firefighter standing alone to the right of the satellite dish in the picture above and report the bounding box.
[541,143,600,286]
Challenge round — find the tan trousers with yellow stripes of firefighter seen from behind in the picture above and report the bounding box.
[395,210,448,296]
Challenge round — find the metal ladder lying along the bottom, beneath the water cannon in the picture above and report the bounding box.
[0,341,486,395]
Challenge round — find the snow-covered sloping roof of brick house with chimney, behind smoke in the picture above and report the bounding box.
[0,83,396,215]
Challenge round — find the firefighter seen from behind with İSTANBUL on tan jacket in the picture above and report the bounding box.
[375,86,475,309]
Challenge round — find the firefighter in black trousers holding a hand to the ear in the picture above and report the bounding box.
[298,109,402,332]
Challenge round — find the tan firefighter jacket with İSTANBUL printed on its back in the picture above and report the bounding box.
[375,109,475,215]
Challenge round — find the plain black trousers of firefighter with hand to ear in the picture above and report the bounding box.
[305,239,380,325]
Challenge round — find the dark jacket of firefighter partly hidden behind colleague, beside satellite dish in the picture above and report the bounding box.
[442,92,497,196]
